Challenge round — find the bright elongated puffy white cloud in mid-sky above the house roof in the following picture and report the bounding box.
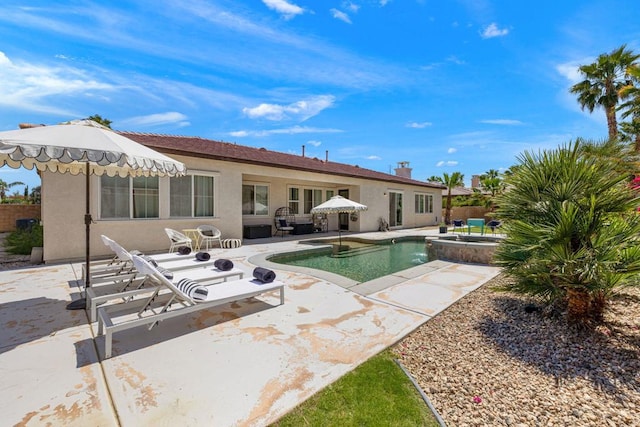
[242,95,335,122]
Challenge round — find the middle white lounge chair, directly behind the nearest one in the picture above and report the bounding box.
[85,235,244,322]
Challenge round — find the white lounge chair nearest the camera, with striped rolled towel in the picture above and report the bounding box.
[98,255,284,359]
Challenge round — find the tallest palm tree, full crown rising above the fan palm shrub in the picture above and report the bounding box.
[570,45,640,139]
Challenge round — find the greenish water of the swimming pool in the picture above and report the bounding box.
[269,239,428,282]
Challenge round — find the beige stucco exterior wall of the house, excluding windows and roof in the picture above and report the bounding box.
[42,156,442,262]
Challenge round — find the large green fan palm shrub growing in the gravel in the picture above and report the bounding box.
[496,140,640,324]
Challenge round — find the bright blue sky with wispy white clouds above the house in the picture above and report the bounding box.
[0,0,640,188]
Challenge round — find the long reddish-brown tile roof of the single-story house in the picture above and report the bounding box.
[118,131,445,188]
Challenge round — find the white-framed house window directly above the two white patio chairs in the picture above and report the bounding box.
[169,175,215,217]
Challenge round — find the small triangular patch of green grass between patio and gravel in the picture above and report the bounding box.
[272,350,438,427]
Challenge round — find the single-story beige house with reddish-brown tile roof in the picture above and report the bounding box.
[41,132,443,262]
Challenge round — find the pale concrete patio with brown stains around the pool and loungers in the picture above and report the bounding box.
[0,230,498,426]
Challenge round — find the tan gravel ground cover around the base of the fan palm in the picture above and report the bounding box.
[394,276,640,427]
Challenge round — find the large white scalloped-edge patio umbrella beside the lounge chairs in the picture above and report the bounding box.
[0,120,186,308]
